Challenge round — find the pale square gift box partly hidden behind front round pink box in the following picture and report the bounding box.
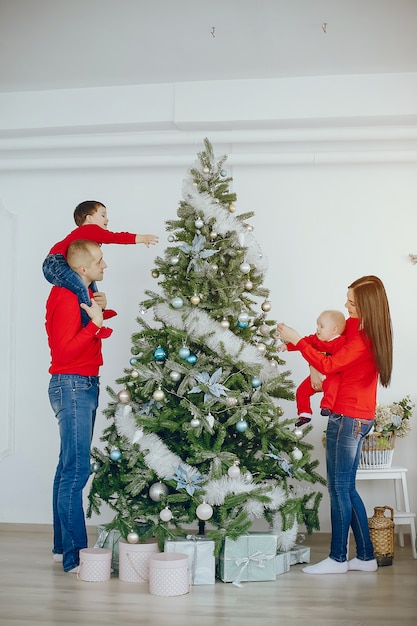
[164,535,215,585]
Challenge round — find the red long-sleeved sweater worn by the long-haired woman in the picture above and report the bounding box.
[296,318,378,420]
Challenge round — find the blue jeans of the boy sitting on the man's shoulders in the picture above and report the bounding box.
[42,254,97,326]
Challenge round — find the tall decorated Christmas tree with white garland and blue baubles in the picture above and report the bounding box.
[87,139,324,549]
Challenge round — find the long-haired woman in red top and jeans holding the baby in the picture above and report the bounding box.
[277,276,392,574]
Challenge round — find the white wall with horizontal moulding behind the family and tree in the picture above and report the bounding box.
[0,75,417,531]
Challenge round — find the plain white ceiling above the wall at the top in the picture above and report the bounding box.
[0,0,417,92]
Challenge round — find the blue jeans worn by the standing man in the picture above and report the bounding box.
[48,374,99,572]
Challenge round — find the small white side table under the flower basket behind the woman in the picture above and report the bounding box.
[356,465,417,559]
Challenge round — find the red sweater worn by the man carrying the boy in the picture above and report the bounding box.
[45,287,112,376]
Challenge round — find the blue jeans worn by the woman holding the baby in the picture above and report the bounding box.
[326,413,374,563]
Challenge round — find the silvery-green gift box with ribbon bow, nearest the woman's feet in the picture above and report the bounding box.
[219,532,277,585]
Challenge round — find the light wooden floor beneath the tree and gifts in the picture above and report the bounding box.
[0,524,417,626]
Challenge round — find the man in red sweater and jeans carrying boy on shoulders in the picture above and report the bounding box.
[45,241,112,573]
